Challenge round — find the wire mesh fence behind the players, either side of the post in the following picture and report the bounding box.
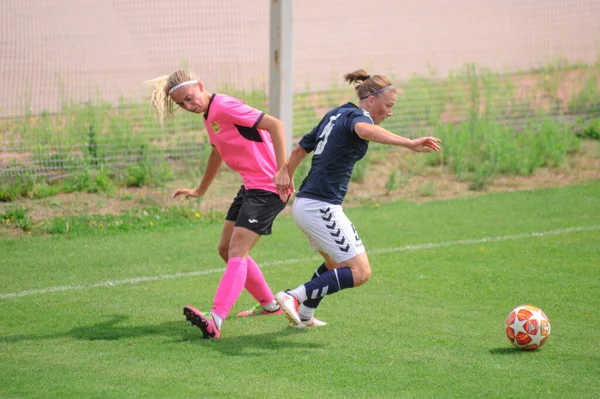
[0,0,600,179]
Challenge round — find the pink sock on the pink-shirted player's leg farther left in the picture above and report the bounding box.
[211,258,248,320]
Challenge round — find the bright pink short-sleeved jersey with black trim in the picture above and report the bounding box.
[204,94,277,193]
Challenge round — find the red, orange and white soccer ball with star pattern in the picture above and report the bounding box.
[505,305,550,351]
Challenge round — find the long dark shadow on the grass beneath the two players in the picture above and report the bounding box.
[0,315,323,356]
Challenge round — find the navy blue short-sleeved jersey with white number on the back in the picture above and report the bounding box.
[296,103,373,205]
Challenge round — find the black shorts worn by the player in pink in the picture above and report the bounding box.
[225,186,287,236]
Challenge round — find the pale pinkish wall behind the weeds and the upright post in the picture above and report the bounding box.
[0,0,600,116]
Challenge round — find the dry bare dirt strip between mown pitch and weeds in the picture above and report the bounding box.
[0,141,600,227]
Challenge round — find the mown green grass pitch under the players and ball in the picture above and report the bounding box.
[0,182,600,399]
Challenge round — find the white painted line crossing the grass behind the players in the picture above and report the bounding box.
[0,225,600,300]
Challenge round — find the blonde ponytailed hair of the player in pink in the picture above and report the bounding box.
[145,69,196,126]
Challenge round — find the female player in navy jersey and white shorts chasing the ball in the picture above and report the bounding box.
[275,69,440,328]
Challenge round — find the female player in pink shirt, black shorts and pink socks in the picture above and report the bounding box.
[149,70,292,338]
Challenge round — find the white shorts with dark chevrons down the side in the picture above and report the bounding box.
[292,197,365,263]
